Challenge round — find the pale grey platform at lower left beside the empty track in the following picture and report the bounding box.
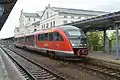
[0,45,25,80]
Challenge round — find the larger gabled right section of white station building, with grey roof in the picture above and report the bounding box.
[39,5,107,30]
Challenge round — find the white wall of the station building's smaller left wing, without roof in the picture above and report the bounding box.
[15,11,40,35]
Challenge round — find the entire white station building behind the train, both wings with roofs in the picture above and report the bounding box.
[14,4,108,35]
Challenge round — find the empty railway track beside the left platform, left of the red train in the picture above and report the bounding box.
[2,48,66,80]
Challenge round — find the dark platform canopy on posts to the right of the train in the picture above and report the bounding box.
[66,11,120,31]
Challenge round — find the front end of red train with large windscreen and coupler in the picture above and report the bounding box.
[65,28,88,57]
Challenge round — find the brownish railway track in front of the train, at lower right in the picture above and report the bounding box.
[78,63,120,80]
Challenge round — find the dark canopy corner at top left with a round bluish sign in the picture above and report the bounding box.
[0,0,17,30]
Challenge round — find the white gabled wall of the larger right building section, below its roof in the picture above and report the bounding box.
[39,6,99,30]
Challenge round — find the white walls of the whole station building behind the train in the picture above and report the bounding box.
[15,5,108,34]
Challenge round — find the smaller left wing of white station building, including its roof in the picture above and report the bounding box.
[14,10,41,36]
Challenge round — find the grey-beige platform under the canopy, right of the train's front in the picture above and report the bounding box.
[88,51,120,68]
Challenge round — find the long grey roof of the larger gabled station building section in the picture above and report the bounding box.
[52,7,109,15]
